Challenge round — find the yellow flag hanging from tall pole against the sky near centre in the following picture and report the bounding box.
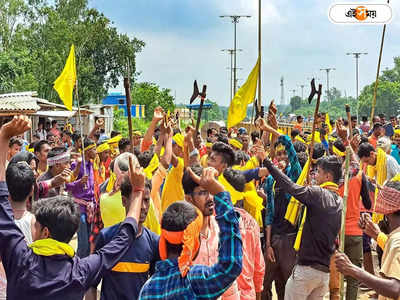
[228,58,260,128]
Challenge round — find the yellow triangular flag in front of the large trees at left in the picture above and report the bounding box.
[54,45,76,110]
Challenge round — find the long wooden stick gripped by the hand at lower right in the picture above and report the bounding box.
[339,146,351,300]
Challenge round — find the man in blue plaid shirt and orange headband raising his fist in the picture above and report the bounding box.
[139,168,242,299]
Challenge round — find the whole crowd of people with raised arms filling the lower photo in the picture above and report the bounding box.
[0,104,400,300]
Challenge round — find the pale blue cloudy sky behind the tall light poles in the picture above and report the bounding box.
[90,0,400,105]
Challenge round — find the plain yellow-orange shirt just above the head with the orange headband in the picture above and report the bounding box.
[161,158,185,214]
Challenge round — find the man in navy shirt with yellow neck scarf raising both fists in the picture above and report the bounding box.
[0,116,144,300]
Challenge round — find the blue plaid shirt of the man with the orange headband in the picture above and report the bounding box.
[139,192,242,300]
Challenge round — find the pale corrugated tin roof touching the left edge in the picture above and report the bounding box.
[0,92,40,113]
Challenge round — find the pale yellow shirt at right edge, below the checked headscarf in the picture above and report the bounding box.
[378,228,400,300]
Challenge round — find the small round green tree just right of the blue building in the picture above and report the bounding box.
[132,82,175,121]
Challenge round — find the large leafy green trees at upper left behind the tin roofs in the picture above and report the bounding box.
[0,0,144,104]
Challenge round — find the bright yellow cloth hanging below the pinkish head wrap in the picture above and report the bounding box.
[100,192,126,228]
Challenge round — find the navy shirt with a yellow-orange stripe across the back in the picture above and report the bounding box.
[96,223,160,300]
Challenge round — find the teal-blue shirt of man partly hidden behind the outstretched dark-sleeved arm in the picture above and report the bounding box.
[264,135,302,233]
